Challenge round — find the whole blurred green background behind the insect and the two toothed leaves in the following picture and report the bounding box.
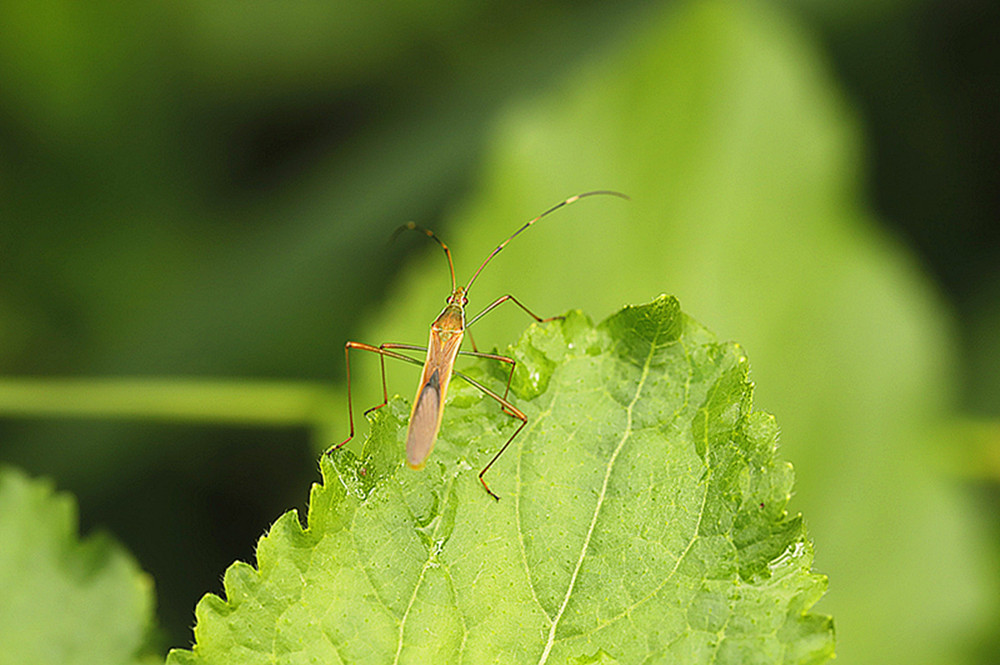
[0,0,1000,663]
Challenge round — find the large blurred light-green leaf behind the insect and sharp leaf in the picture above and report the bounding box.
[356,3,995,663]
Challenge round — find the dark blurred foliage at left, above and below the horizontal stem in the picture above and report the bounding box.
[0,0,648,644]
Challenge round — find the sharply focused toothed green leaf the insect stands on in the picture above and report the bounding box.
[168,297,833,663]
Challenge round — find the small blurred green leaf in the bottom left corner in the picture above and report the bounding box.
[0,468,153,665]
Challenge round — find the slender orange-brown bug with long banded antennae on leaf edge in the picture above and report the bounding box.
[327,190,628,501]
